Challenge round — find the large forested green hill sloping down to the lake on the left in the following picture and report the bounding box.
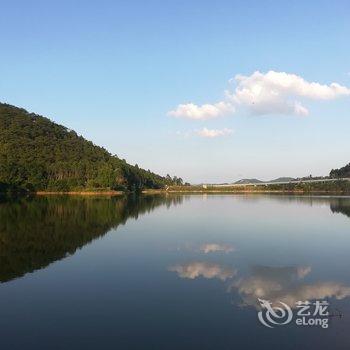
[0,103,182,192]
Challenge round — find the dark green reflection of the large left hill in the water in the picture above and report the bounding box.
[0,196,183,282]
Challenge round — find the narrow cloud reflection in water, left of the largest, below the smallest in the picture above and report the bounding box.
[169,261,236,281]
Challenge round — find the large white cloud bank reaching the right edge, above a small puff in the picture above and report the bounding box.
[168,71,350,120]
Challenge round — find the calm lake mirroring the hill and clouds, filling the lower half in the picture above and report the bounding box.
[0,195,350,350]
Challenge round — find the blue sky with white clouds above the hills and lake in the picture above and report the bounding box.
[0,0,350,182]
